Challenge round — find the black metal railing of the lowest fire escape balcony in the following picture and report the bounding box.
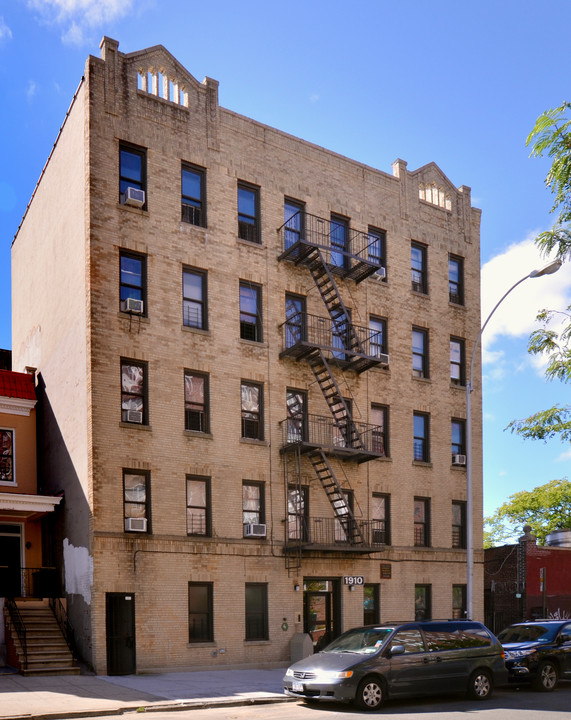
[286,515,388,551]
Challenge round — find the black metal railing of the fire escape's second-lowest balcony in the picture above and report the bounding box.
[280,414,385,457]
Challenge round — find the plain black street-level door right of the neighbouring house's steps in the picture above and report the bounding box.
[105,593,137,675]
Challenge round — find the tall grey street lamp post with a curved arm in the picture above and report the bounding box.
[466,260,562,620]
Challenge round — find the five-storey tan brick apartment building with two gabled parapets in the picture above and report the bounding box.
[8,38,483,673]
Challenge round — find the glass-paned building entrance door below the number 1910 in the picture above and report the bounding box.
[303,579,339,652]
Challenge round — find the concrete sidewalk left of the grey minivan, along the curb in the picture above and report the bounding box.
[0,666,291,720]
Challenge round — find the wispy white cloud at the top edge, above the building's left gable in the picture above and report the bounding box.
[28,0,134,45]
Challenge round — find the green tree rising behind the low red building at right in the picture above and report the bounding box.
[484,478,571,547]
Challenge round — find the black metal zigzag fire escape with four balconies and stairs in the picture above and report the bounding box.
[278,212,389,570]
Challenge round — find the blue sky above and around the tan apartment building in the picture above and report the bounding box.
[0,0,571,528]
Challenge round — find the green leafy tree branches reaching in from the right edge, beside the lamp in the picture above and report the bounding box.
[508,102,571,442]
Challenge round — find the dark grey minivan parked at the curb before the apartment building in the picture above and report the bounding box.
[283,620,507,710]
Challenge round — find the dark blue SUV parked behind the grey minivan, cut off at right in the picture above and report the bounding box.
[498,620,571,692]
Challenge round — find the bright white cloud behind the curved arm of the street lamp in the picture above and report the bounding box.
[481,233,571,374]
